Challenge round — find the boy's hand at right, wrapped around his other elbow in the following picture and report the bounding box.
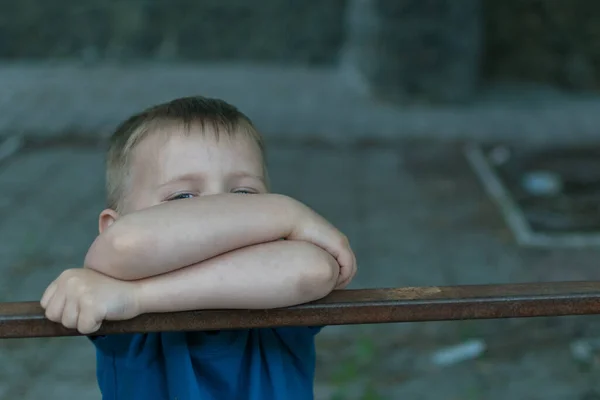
[288,203,356,289]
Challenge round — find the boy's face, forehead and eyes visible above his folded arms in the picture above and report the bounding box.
[125,127,267,212]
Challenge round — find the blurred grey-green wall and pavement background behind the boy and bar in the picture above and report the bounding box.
[0,0,600,400]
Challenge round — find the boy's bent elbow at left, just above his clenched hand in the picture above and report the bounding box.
[84,226,149,280]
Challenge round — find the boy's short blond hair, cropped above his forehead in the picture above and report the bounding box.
[106,96,265,211]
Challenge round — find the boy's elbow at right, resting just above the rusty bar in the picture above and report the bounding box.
[297,245,340,302]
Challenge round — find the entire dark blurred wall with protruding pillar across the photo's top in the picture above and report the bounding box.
[0,0,600,103]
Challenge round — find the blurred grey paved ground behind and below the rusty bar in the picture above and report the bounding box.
[0,140,600,400]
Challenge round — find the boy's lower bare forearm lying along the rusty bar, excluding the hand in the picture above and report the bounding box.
[138,241,339,313]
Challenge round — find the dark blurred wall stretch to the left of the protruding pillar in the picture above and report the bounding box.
[0,0,346,65]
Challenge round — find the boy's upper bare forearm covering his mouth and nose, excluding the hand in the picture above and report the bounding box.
[85,194,300,280]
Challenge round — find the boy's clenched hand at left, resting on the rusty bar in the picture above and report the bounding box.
[40,268,139,334]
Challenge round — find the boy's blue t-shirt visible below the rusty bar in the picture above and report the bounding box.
[92,327,319,400]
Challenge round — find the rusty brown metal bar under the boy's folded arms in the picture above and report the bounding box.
[0,282,600,338]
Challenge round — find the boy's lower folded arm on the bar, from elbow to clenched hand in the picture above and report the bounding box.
[41,241,339,334]
